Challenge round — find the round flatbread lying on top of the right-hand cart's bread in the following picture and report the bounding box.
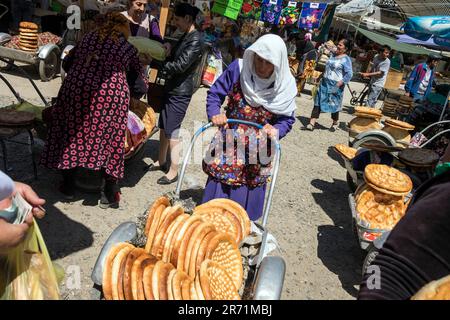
[364,164,413,194]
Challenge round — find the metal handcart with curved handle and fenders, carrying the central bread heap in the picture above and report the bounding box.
[91,119,286,300]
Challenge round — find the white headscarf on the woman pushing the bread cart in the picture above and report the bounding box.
[239,34,297,116]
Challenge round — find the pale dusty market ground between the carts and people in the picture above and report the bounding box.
[0,68,370,300]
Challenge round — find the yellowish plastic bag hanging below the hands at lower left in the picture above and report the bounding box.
[0,221,60,300]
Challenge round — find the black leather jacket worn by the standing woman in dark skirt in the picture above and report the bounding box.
[161,30,202,95]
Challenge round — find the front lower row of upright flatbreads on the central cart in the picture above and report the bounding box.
[102,242,241,300]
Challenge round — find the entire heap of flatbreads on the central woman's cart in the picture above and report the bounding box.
[102,196,250,300]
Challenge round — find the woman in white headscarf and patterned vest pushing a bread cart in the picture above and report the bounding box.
[203,34,297,220]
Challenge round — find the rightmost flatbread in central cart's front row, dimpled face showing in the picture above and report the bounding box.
[200,260,241,300]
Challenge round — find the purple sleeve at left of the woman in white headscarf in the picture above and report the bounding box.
[206,60,240,119]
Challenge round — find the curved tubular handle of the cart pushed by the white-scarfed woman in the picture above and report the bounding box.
[175,119,281,228]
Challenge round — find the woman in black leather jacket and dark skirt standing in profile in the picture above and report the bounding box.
[148,3,202,184]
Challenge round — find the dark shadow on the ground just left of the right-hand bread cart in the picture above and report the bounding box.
[311,179,364,297]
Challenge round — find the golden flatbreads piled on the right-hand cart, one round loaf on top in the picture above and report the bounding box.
[355,164,413,230]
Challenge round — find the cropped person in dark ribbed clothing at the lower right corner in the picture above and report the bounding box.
[358,145,450,300]
